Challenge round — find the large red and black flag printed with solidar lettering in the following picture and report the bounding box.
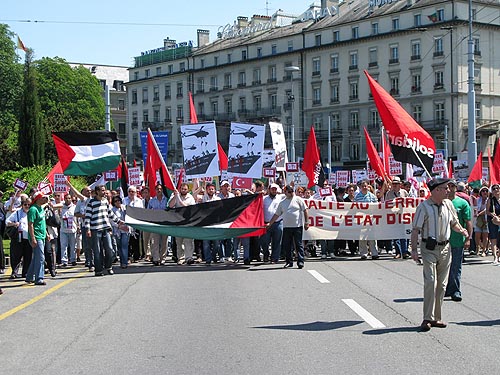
[365,70,436,175]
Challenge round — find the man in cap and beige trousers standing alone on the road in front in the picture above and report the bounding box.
[411,178,469,332]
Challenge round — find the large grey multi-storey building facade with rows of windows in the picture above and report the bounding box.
[127,0,500,172]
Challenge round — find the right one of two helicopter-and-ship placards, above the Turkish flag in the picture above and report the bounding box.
[227,122,266,178]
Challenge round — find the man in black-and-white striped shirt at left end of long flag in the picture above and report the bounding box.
[84,185,125,276]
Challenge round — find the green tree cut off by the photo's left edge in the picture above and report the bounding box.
[0,24,22,172]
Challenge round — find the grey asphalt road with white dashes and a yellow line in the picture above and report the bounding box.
[0,255,500,375]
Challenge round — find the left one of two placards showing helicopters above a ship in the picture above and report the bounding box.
[181,122,219,178]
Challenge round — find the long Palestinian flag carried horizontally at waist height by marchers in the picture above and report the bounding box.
[125,194,265,240]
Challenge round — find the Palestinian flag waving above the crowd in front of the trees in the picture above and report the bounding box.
[52,130,121,176]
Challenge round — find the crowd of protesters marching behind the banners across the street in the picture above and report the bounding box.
[0,177,500,300]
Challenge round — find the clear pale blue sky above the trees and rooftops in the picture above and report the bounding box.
[0,0,314,67]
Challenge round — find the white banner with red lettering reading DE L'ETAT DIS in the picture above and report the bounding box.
[302,198,424,240]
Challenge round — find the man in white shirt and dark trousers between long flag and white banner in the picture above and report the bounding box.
[266,185,309,269]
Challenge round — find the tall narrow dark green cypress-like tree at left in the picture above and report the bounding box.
[18,49,46,167]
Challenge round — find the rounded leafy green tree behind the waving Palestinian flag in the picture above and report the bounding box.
[36,57,105,163]
